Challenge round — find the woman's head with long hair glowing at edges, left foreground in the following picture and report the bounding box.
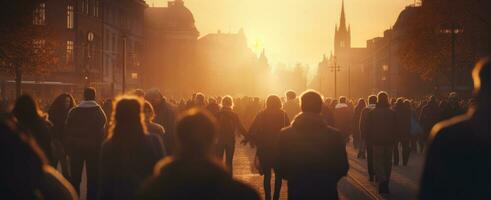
[108,96,146,141]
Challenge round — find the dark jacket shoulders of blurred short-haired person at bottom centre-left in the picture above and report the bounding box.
[140,158,260,200]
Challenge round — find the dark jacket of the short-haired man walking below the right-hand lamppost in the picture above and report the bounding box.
[366,104,397,146]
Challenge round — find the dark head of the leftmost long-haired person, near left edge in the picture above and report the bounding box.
[12,95,43,126]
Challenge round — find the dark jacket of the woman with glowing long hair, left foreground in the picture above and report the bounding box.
[100,134,164,200]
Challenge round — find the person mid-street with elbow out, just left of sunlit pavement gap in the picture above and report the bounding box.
[217,96,247,174]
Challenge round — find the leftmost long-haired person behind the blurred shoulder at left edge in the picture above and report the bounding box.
[12,95,54,164]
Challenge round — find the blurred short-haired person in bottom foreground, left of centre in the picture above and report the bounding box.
[141,109,260,200]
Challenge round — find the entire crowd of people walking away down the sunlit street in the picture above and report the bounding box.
[0,60,491,200]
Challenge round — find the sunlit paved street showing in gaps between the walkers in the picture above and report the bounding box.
[74,141,423,200]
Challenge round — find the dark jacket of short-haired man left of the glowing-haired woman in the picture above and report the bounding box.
[65,101,106,152]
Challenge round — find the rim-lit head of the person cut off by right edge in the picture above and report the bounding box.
[472,58,491,104]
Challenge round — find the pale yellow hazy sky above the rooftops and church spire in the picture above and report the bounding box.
[146,0,414,67]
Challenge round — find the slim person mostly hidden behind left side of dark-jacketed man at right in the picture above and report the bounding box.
[360,95,377,182]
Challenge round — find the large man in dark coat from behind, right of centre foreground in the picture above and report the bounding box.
[278,91,349,200]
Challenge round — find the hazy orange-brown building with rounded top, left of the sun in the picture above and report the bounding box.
[143,0,199,95]
